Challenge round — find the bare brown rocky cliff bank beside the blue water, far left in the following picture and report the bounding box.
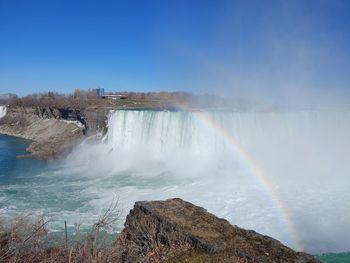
[0,107,85,160]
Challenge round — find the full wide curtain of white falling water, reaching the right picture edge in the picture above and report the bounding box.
[106,110,350,185]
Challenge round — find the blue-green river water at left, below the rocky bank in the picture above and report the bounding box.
[0,135,120,245]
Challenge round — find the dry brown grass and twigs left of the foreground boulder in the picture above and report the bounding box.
[0,200,124,263]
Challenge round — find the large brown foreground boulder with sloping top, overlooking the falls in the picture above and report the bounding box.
[116,199,319,263]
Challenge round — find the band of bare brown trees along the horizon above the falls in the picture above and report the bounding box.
[8,89,239,111]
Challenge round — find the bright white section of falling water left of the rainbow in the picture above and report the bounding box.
[107,111,229,155]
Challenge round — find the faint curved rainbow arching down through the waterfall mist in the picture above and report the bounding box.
[170,101,304,251]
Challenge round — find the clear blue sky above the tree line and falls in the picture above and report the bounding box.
[0,0,350,105]
